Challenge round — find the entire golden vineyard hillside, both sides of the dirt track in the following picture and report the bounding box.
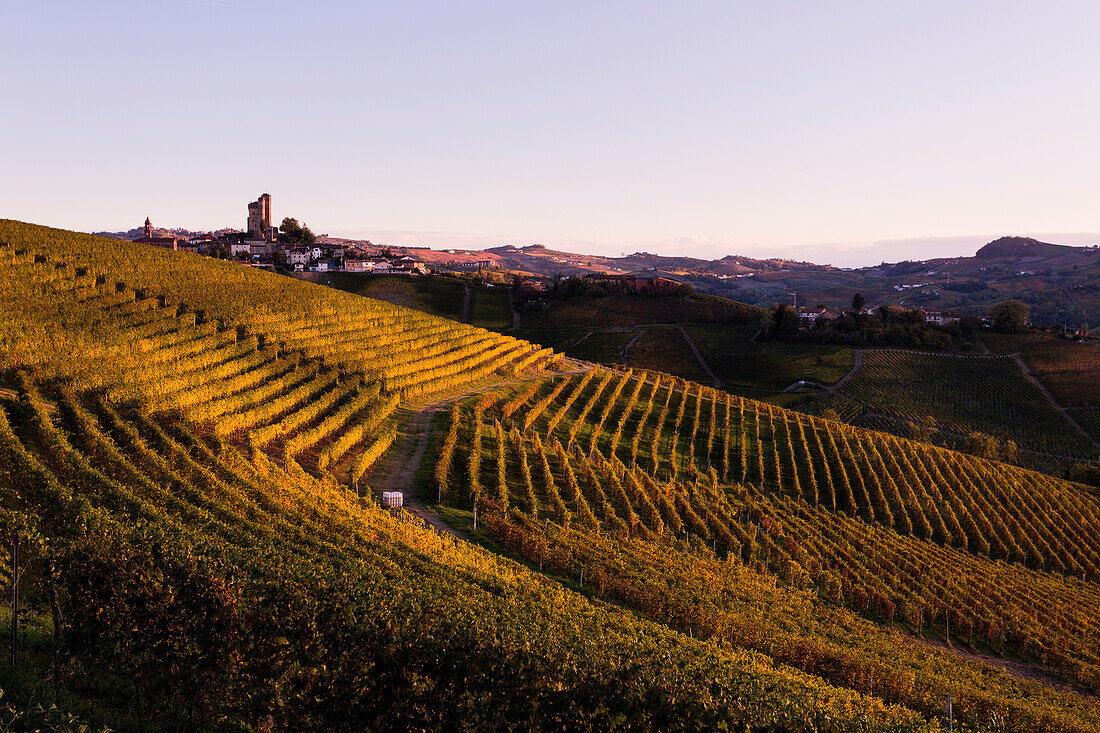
[0,221,1100,732]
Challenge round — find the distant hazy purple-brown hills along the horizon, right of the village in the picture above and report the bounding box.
[426,237,1100,326]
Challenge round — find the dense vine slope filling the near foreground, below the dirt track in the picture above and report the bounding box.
[0,379,925,731]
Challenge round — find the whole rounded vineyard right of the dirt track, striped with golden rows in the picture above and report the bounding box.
[436,371,1100,730]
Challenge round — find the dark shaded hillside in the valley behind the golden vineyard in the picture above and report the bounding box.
[310,273,1100,475]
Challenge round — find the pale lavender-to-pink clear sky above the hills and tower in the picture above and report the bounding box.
[0,0,1100,266]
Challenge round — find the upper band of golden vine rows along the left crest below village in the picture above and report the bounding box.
[0,220,552,396]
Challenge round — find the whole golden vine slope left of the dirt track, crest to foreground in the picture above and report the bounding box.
[0,220,946,732]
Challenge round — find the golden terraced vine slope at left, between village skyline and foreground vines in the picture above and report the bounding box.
[0,226,552,481]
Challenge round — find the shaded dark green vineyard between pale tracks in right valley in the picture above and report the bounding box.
[807,350,1096,466]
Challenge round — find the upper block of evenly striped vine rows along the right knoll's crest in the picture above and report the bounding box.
[475,371,1100,580]
